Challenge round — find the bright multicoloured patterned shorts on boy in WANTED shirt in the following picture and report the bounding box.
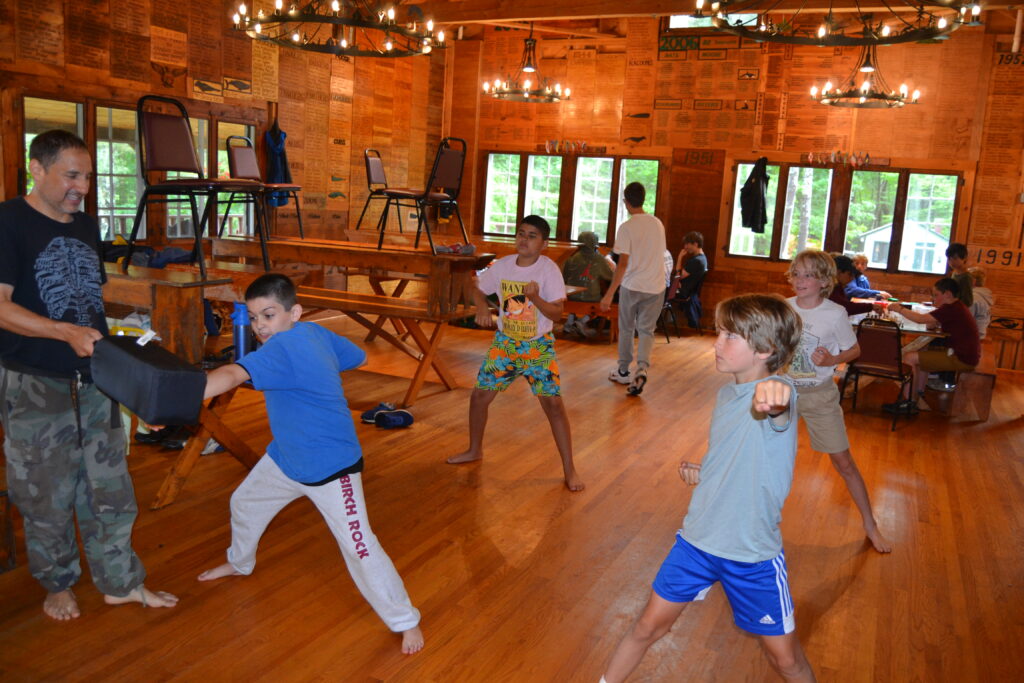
[476,331,562,396]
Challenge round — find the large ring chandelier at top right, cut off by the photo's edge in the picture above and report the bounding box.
[693,0,981,46]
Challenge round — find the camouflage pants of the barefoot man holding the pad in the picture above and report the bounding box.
[0,368,145,597]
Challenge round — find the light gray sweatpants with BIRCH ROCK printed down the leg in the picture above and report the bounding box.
[227,455,420,633]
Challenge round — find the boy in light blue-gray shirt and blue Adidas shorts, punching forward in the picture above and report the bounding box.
[601,294,815,683]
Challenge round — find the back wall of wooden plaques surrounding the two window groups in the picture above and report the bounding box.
[466,18,1024,316]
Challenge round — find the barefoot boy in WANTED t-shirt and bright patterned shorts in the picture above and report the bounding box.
[446,216,584,492]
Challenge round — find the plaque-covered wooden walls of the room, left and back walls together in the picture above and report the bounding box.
[0,0,1024,323]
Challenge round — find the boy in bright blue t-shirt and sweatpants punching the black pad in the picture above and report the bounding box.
[199,273,423,654]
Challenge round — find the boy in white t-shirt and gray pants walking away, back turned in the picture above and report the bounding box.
[600,182,672,396]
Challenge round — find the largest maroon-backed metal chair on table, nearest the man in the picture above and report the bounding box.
[122,95,262,278]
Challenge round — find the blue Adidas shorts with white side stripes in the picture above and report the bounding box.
[651,536,796,636]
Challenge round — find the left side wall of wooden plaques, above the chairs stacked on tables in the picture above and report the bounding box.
[0,0,444,242]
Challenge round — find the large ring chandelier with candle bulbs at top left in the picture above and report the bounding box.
[231,0,445,57]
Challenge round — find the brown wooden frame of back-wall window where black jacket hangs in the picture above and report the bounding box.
[723,156,969,275]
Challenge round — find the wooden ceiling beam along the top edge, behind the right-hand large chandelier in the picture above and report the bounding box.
[420,0,1024,24]
